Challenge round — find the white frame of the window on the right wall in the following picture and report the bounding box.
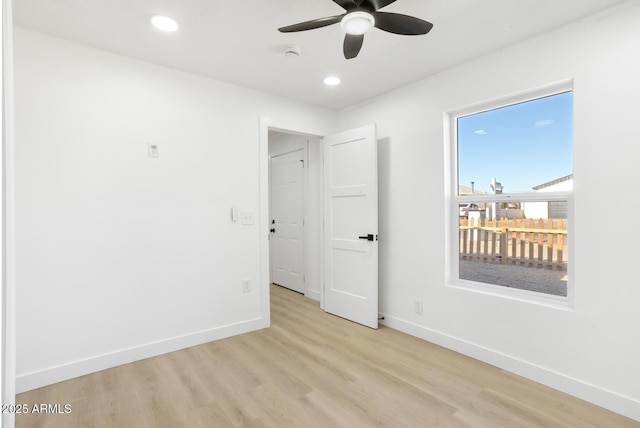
[444,80,575,310]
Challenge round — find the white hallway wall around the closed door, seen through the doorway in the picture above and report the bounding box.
[269,132,323,301]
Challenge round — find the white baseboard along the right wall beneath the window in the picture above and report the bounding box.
[380,313,640,421]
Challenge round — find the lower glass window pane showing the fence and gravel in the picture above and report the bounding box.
[458,207,568,297]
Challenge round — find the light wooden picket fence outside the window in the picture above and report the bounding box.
[460,218,567,270]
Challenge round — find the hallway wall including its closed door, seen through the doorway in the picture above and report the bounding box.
[268,129,322,301]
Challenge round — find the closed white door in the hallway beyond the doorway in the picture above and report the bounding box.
[270,150,305,294]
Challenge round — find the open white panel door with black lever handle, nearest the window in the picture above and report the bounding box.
[324,125,378,328]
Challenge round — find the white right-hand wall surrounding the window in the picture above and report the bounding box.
[340,1,640,420]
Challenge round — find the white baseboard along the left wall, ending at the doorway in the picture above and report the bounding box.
[16,318,269,393]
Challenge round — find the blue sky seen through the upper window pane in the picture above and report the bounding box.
[458,92,573,193]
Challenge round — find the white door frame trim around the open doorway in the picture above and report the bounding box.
[258,116,326,325]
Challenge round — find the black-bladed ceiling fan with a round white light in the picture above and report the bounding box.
[278,0,433,59]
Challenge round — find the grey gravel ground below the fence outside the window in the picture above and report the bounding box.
[460,260,567,296]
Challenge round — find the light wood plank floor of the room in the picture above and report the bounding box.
[17,287,640,428]
